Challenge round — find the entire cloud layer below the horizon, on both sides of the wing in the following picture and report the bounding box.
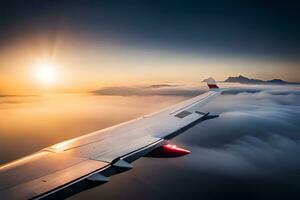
[0,84,300,200]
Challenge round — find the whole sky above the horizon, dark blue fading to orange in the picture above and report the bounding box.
[0,0,300,95]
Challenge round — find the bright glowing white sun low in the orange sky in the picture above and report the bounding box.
[35,62,57,85]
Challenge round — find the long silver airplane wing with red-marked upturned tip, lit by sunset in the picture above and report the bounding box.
[0,79,222,199]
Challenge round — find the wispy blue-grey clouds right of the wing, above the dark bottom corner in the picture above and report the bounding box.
[175,84,300,180]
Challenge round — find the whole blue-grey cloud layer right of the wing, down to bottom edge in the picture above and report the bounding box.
[73,86,300,199]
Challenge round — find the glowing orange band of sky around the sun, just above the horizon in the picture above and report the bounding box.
[0,36,300,94]
